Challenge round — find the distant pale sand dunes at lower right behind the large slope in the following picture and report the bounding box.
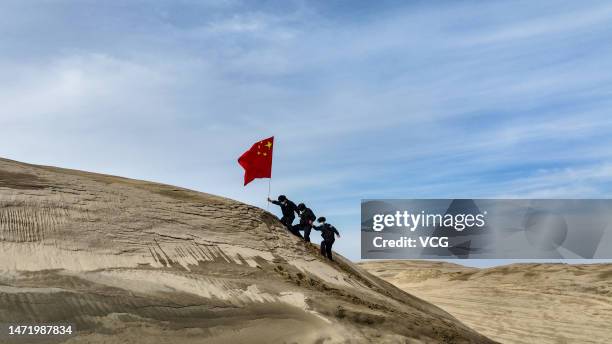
[359,260,612,344]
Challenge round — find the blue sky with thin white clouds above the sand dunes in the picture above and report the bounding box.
[0,0,612,259]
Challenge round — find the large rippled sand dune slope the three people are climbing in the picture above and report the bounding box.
[0,159,493,343]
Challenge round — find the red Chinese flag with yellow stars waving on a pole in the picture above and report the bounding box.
[238,136,274,185]
